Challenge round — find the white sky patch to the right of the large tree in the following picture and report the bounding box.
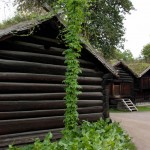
[124,0,150,57]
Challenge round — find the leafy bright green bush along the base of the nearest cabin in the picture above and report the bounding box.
[9,119,133,150]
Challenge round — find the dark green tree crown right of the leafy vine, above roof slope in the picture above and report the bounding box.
[88,0,133,59]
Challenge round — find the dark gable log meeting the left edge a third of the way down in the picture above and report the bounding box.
[0,50,94,68]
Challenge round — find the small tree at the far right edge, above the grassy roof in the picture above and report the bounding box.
[141,43,150,62]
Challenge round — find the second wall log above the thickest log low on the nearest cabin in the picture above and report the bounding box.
[0,100,103,111]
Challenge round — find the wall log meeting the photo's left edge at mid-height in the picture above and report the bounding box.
[0,72,102,85]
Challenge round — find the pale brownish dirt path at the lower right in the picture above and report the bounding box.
[110,112,150,150]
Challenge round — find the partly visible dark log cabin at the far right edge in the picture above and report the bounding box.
[136,66,150,103]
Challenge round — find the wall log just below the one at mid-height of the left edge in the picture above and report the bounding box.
[0,82,103,93]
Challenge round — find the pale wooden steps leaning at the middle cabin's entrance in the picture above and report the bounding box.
[121,98,138,111]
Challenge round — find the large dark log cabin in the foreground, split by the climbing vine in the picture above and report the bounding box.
[0,16,117,149]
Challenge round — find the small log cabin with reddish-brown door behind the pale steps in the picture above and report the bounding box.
[110,61,138,107]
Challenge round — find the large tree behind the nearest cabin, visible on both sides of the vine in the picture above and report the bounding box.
[15,0,133,59]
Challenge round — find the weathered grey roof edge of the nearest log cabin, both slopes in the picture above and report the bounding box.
[0,16,118,76]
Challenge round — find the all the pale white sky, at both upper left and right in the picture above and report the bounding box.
[0,0,150,58]
